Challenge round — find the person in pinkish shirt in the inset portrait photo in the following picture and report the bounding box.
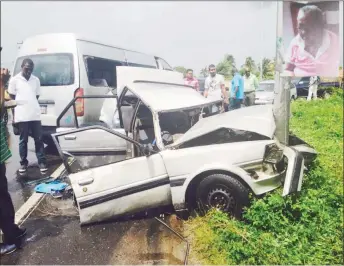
[284,5,340,77]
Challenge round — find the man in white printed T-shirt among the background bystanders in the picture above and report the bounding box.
[204,65,229,112]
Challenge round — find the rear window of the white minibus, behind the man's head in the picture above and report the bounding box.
[14,54,74,86]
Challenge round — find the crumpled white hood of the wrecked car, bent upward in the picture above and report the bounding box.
[170,105,276,147]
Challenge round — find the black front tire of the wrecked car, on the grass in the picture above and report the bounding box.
[196,174,249,219]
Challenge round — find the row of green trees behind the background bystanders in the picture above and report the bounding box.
[174,54,275,80]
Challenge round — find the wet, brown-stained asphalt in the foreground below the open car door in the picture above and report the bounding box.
[0,196,186,265]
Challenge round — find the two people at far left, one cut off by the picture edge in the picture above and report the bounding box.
[0,48,48,256]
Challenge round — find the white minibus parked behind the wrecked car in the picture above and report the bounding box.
[12,33,173,145]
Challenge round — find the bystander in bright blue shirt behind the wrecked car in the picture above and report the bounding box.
[229,68,244,110]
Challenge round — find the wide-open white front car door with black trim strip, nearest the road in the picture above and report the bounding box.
[52,126,172,224]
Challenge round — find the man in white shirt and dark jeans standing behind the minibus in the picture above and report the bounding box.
[8,58,48,174]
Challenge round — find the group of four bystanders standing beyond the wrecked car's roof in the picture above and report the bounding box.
[184,64,258,112]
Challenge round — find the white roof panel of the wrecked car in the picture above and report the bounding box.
[127,80,218,112]
